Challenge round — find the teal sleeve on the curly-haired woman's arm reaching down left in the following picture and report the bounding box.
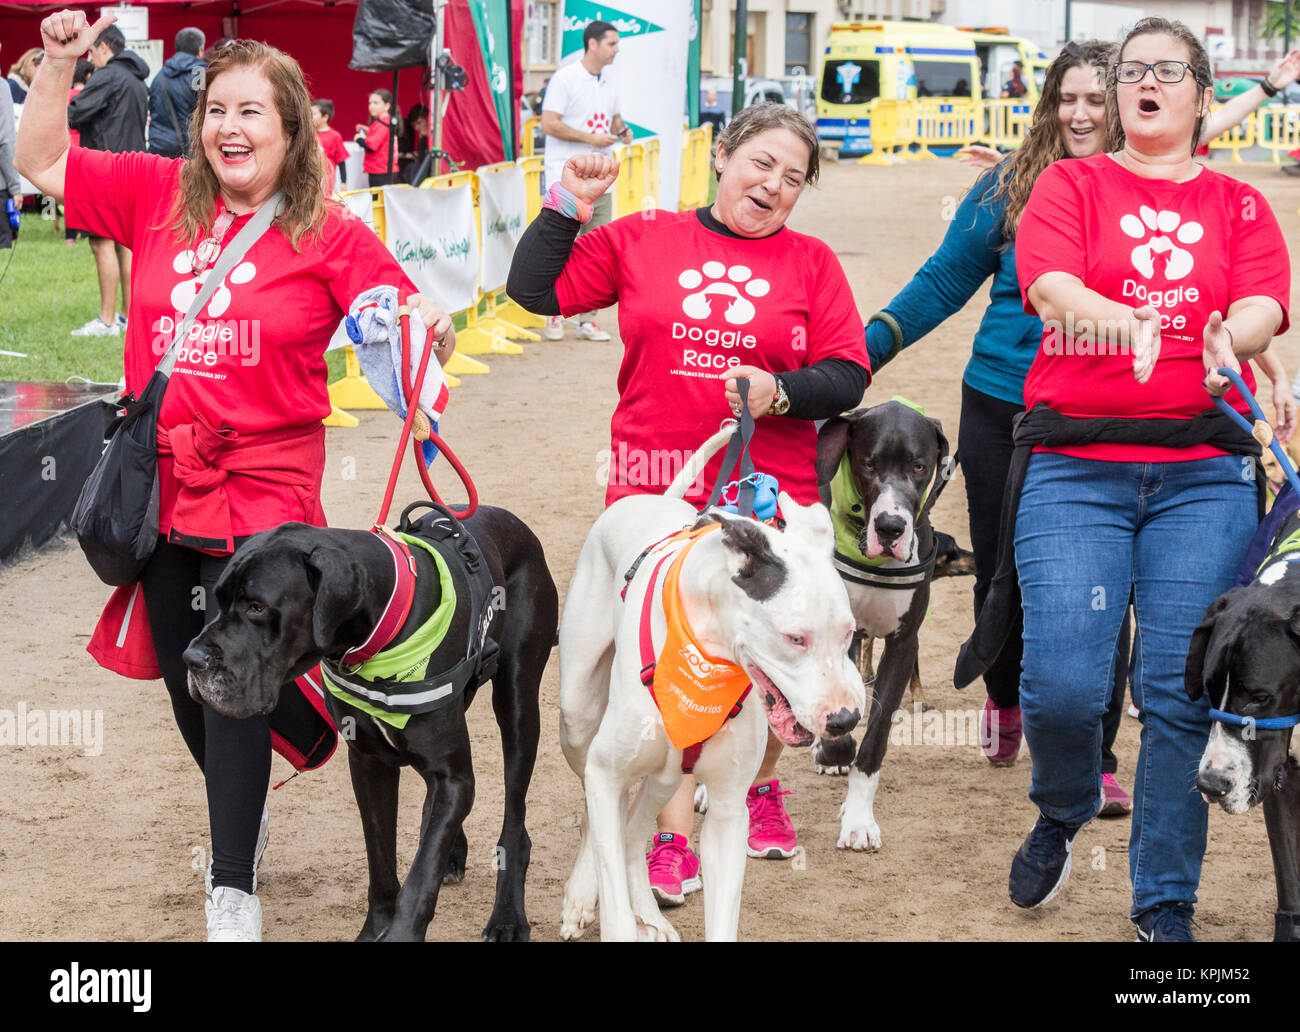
[866,169,1004,369]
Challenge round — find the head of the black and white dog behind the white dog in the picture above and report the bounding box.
[816,402,949,561]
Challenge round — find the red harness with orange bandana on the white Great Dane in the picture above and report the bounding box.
[629,524,750,773]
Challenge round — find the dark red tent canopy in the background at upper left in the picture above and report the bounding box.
[0,0,524,168]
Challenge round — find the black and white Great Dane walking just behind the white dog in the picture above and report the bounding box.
[813,402,950,850]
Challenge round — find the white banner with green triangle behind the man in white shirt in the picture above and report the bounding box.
[560,0,694,212]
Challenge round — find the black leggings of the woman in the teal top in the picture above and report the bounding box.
[957,381,1131,773]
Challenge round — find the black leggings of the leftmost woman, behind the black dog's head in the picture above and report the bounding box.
[140,538,318,892]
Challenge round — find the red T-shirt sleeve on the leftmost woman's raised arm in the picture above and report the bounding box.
[64,147,179,250]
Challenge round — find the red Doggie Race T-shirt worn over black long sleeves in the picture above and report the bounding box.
[555,211,867,504]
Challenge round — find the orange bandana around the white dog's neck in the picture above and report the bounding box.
[646,524,749,749]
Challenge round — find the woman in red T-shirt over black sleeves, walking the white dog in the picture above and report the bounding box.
[507,104,870,903]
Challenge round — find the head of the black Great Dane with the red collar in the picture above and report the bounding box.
[185,524,391,717]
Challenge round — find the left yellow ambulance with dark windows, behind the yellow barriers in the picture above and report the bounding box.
[816,21,980,155]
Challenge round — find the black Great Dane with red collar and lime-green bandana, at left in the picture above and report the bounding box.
[185,506,559,941]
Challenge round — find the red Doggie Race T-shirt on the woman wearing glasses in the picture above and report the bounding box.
[1015,153,1291,463]
